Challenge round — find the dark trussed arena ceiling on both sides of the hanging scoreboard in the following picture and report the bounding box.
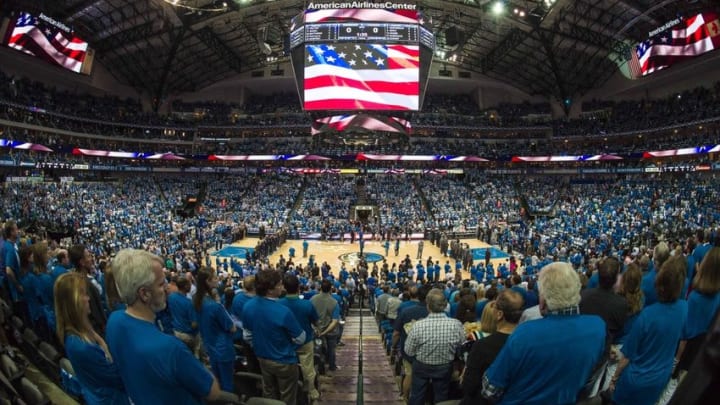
[6,0,716,99]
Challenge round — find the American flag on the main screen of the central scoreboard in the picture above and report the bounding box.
[304,43,420,110]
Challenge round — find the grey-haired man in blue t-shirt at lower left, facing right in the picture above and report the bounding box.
[106,249,240,405]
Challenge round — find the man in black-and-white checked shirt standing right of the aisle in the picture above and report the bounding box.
[405,289,465,405]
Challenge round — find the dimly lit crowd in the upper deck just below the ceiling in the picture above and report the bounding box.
[5,68,720,147]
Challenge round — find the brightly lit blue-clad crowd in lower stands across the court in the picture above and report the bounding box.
[3,173,720,257]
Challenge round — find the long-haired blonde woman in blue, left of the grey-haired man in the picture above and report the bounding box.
[54,273,129,405]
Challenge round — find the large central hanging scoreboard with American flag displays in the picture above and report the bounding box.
[290,2,435,111]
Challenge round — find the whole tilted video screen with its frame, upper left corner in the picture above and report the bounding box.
[3,12,93,74]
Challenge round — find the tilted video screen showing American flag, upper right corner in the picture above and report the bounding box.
[629,13,720,77]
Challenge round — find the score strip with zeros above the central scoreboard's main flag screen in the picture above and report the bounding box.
[305,23,419,44]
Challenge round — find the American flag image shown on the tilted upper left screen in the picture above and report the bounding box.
[8,13,88,73]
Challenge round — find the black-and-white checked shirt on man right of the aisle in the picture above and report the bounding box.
[405,312,465,366]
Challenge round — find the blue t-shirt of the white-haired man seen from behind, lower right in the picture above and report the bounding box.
[485,315,605,405]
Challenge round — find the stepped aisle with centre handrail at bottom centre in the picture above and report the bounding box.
[320,308,404,405]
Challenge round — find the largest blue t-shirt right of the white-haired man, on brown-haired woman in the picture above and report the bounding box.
[613,300,687,405]
